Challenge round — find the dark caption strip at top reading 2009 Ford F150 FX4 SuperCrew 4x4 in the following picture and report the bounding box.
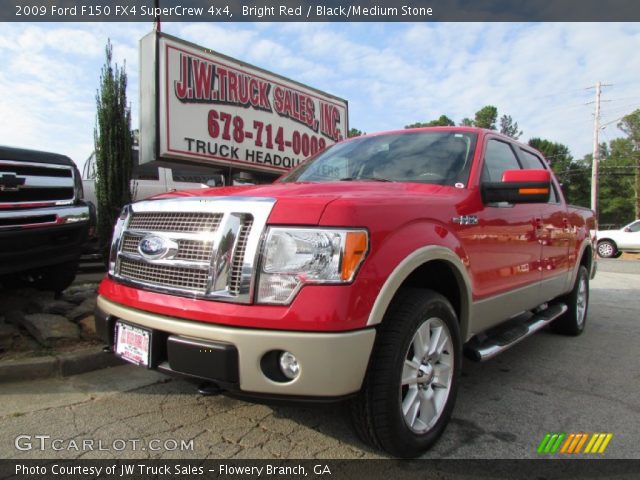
[0,0,640,22]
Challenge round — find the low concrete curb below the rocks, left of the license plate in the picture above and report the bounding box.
[0,347,126,383]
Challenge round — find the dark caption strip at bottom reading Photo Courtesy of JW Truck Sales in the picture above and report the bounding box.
[0,459,640,480]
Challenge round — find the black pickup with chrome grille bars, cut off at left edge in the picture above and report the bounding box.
[0,146,91,292]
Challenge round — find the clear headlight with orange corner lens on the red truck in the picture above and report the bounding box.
[257,227,369,304]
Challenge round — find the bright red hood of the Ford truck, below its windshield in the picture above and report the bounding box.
[153,181,467,225]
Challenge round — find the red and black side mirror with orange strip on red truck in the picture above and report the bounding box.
[481,170,551,203]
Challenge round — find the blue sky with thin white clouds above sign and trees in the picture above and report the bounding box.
[0,22,640,172]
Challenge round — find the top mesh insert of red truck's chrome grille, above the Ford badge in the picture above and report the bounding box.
[129,212,222,233]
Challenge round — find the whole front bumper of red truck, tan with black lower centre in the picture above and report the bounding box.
[96,296,375,398]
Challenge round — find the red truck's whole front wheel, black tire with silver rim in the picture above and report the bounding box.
[351,289,462,458]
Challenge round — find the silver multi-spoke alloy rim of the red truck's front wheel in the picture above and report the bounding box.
[400,317,454,433]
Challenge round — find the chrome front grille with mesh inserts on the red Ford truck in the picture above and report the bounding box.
[112,198,274,303]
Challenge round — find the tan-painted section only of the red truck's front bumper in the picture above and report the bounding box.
[98,296,375,397]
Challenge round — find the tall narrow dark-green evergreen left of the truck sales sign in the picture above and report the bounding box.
[94,40,133,258]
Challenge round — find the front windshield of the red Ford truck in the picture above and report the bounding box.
[280,131,477,187]
